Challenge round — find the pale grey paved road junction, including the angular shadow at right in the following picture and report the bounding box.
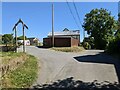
[19,46,120,84]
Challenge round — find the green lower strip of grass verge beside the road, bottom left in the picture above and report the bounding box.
[2,53,38,89]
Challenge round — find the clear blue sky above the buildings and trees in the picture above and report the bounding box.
[0,2,118,41]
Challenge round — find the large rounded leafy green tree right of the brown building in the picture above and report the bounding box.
[83,8,116,49]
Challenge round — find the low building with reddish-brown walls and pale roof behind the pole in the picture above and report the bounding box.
[43,28,80,47]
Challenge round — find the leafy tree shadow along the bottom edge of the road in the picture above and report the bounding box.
[33,77,120,90]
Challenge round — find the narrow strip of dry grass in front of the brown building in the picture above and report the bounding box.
[51,47,84,52]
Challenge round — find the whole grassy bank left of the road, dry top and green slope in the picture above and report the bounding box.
[2,52,38,88]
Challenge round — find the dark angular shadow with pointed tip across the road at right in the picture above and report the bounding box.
[74,53,120,83]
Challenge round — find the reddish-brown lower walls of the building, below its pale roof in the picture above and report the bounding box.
[43,37,79,47]
